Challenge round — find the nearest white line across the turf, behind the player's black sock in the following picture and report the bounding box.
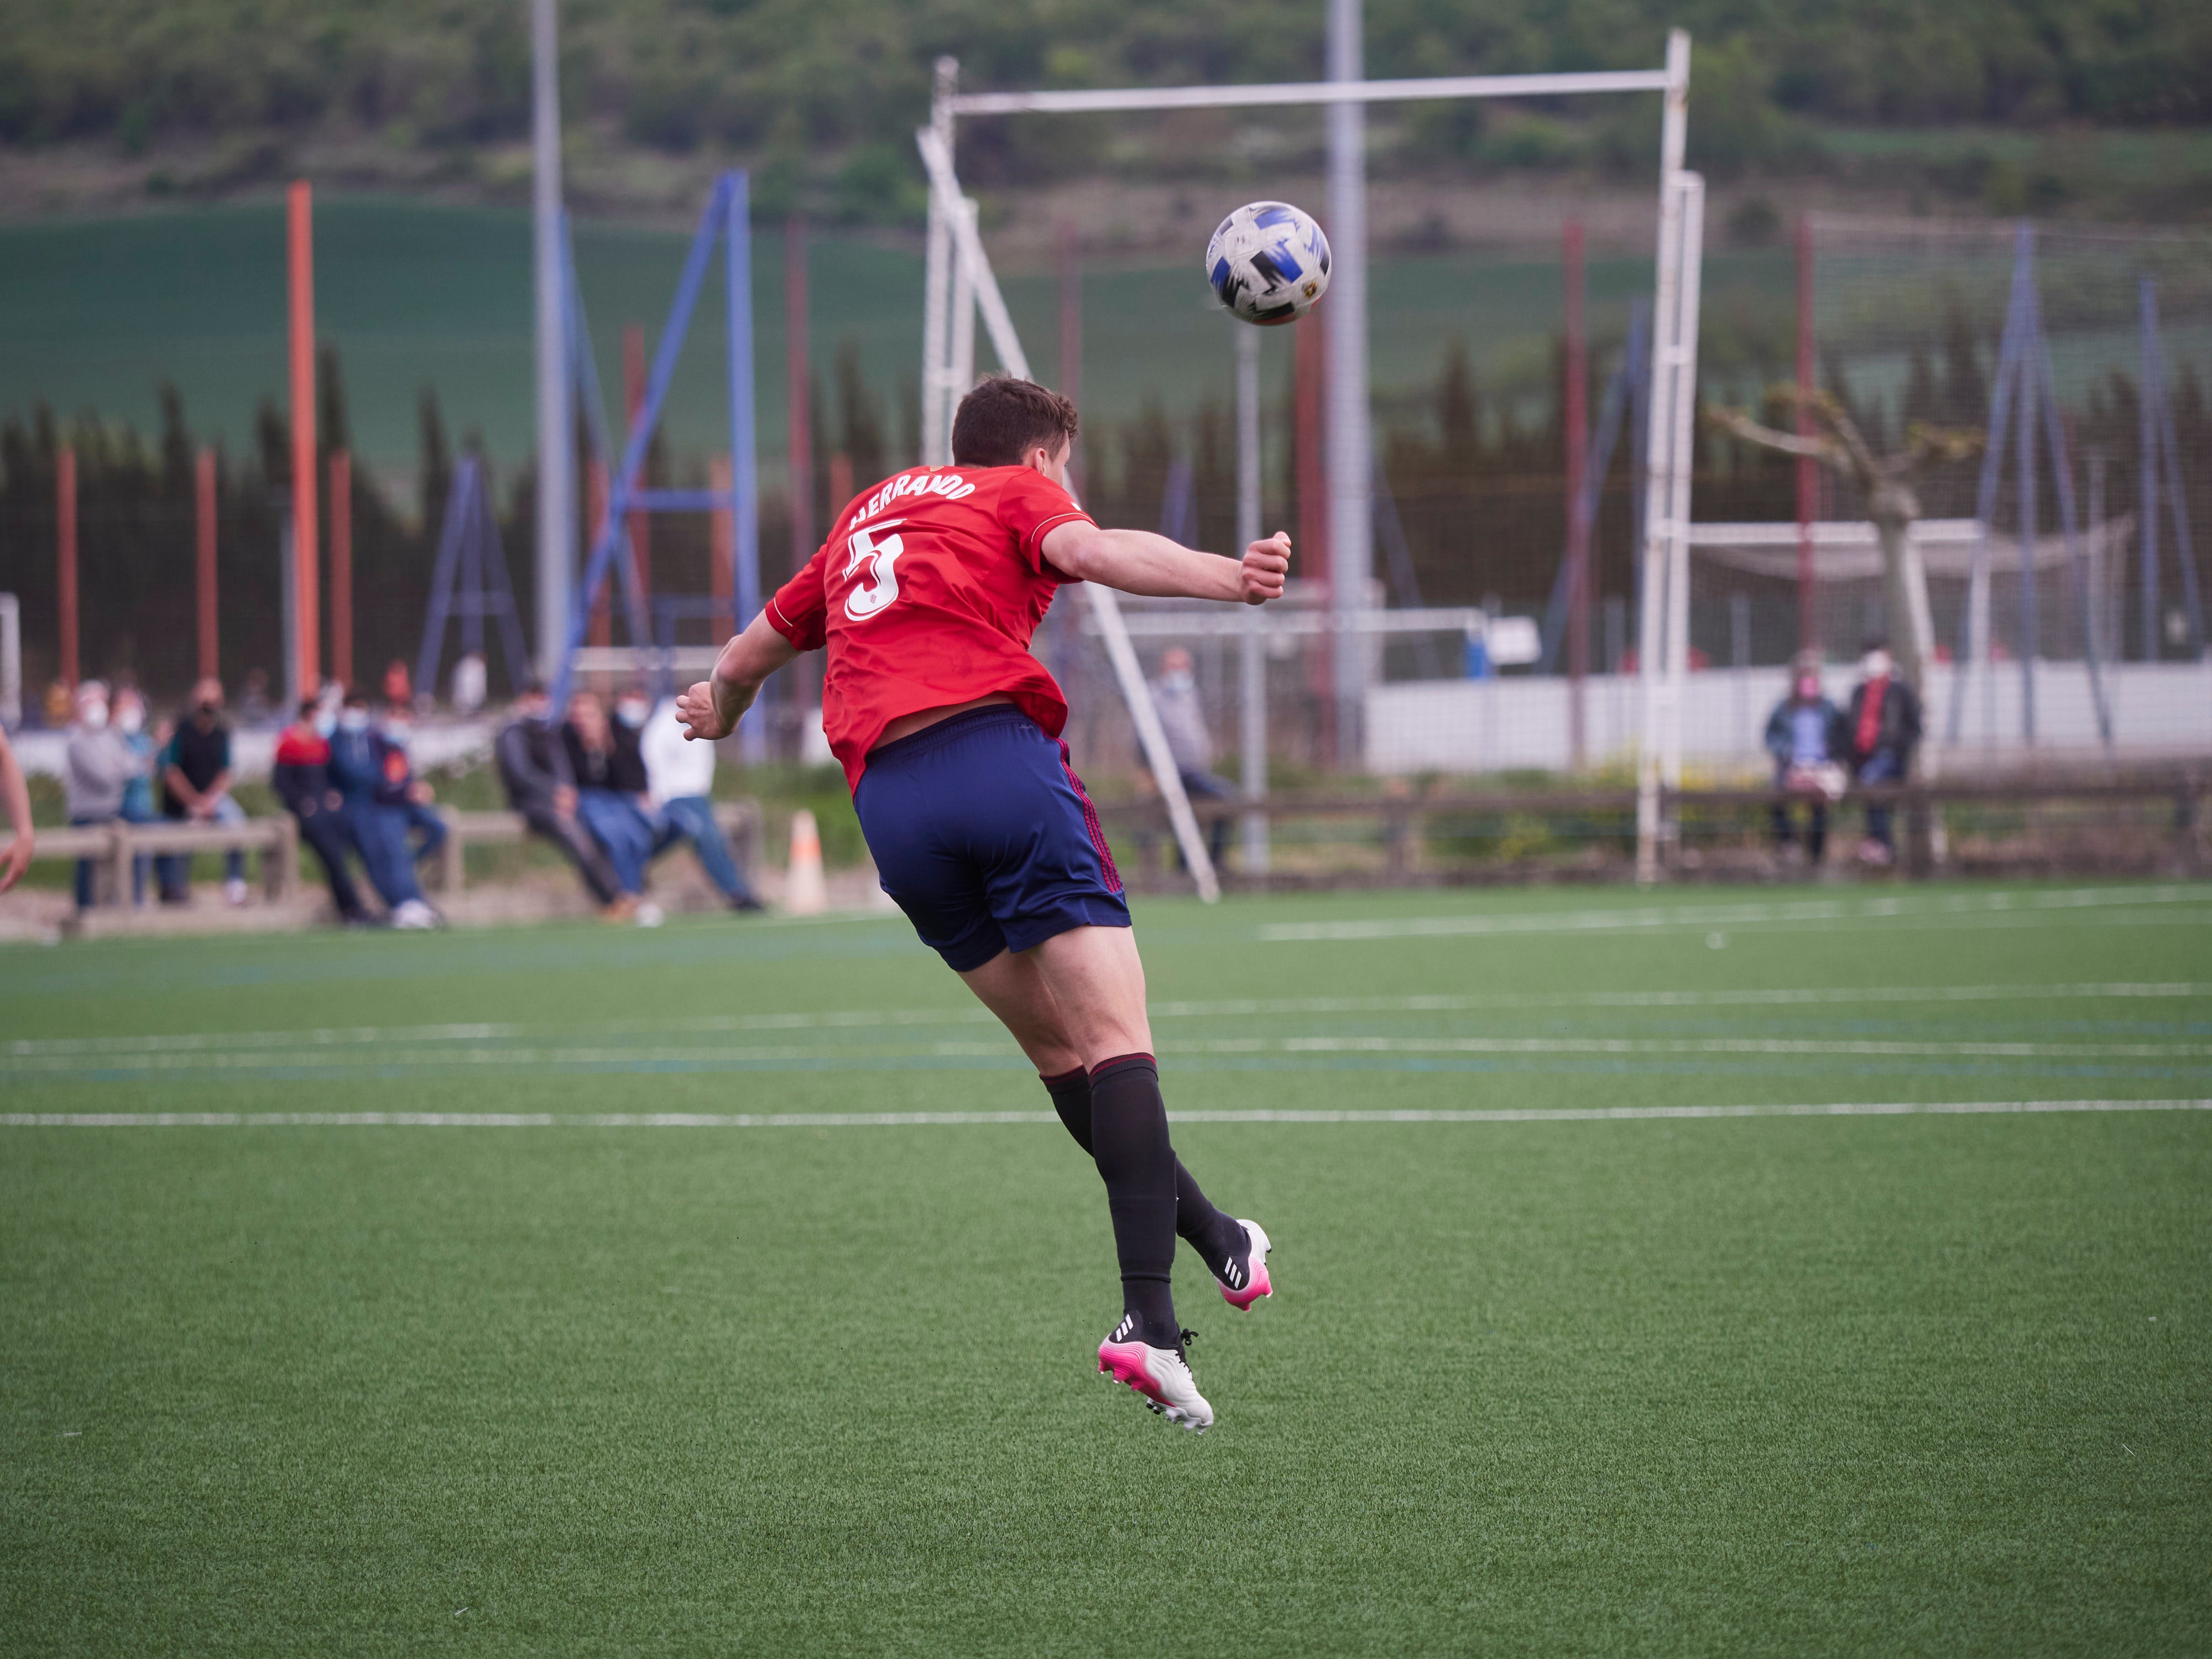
[0,1099,2212,1128]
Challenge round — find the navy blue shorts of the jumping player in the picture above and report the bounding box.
[852,703,1128,973]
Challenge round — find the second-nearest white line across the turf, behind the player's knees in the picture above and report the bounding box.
[0,1037,2212,1079]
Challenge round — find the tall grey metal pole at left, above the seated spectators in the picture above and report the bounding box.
[531,0,575,684]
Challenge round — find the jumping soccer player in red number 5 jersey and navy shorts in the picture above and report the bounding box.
[677,378,1290,1431]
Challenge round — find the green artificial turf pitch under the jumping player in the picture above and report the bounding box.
[0,887,2212,1655]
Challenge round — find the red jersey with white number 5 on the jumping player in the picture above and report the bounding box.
[768,467,1093,785]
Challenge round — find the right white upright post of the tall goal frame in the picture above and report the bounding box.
[1637,29,1690,883]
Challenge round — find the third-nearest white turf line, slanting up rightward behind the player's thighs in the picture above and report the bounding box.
[0,980,2212,1057]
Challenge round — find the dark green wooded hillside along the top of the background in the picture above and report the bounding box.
[0,0,2212,221]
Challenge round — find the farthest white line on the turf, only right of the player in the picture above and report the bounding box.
[1254,885,2212,945]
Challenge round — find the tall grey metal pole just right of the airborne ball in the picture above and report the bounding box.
[1327,0,1374,768]
